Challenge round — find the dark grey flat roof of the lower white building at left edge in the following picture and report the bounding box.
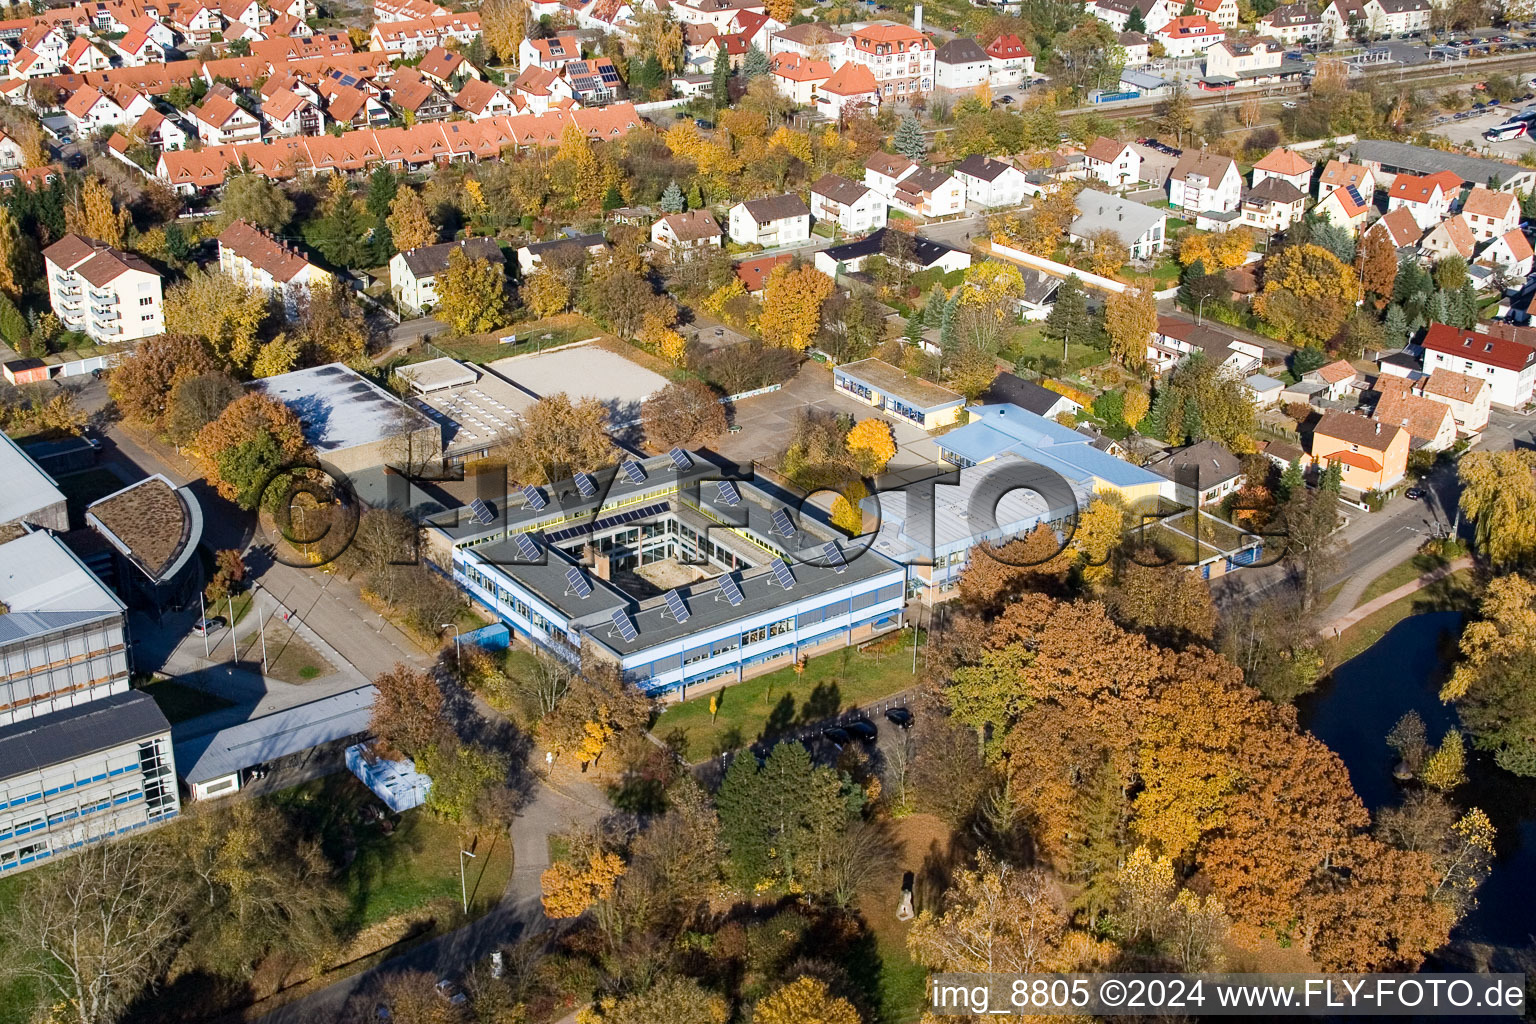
[0,689,170,778]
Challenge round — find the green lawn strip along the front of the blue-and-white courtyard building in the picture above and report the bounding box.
[651,629,917,760]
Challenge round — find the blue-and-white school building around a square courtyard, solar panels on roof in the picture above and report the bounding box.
[427,450,906,695]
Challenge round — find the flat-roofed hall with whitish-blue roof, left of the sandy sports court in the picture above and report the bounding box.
[250,362,442,474]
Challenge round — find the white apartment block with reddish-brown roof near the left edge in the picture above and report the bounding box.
[43,235,166,344]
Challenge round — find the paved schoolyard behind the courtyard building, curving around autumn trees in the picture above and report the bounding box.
[711,359,938,471]
